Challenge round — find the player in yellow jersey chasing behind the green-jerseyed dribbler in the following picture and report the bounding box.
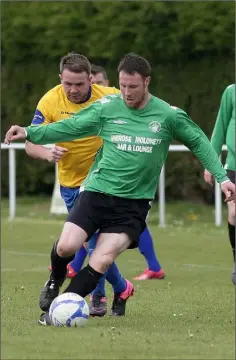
[26,53,133,316]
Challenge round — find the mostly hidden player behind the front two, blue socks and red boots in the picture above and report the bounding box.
[67,64,165,280]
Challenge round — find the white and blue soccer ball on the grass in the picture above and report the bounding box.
[49,293,89,327]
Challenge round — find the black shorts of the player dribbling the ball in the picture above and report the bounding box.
[66,191,151,248]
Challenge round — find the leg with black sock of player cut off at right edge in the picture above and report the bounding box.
[227,170,236,285]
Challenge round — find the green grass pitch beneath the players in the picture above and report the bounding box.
[1,198,234,359]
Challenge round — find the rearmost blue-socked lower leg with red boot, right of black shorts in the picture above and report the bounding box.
[134,227,165,280]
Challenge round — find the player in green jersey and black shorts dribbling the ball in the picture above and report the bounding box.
[5,54,235,325]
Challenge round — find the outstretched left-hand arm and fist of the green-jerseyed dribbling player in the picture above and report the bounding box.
[5,102,102,145]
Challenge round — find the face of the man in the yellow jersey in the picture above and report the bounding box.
[59,69,91,104]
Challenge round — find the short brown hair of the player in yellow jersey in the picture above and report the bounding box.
[60,52,91,75]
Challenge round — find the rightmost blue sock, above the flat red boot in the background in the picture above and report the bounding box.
[139,227,161,271]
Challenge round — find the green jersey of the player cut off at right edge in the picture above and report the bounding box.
[211,85,236,170]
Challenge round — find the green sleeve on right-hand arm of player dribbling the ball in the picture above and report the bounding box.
[174,109,229,183]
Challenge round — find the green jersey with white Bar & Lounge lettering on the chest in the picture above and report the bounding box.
[26,95,227,199]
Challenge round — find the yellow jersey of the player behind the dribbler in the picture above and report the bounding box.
[31,84,120,188]
